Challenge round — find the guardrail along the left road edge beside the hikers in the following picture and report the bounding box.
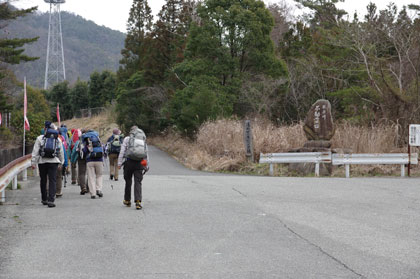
[0,154,32,202]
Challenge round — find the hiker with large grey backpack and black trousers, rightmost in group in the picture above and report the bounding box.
[118,126,149,210]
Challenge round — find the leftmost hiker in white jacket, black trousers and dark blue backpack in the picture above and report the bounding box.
[32,121,64,207]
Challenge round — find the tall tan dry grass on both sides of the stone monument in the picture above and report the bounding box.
[150,119,416,176]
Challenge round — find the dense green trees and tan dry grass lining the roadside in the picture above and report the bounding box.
[0,0,420,177]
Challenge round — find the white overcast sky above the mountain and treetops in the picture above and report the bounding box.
[13,0,420,32]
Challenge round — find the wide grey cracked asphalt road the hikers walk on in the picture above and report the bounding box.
[0,148,420,279]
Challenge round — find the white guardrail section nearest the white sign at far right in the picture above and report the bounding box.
[332,153,418,178]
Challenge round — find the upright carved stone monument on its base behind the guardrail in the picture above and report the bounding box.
[289,99,335,175]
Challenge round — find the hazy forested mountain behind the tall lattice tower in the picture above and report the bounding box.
[2,9,125,88]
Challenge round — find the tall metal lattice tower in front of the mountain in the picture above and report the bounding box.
[44,0,66,89]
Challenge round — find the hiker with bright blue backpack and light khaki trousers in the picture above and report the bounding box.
[82,130,104,199]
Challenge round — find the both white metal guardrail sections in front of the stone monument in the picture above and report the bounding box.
[260,152,418,178]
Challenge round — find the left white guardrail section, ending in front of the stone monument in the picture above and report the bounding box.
[260,152,331,176]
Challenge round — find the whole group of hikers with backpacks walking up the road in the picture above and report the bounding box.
[32,121,149,209]
